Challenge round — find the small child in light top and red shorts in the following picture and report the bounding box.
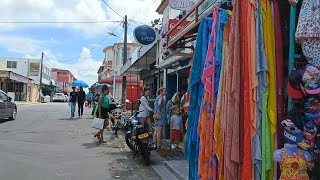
[170,106,183,149]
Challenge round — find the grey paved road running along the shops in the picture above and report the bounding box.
[0,103,161,180]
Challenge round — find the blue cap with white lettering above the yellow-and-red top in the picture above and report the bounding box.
[281,119,303,144]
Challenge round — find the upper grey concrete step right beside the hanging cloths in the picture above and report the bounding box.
[164,160,189,180]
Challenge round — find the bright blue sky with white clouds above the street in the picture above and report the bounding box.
[0,0,161,85]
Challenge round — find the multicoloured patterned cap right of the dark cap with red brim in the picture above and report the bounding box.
[302,65,320,94]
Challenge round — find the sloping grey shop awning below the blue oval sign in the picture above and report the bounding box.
[120,43,157,76]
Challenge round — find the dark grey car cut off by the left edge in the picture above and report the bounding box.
[0,90,18,120]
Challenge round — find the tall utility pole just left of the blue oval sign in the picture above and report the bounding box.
[122,15,127,104]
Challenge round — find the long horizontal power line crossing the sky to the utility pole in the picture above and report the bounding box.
[0,21,122,24]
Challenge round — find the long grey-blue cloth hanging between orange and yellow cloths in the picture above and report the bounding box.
[252,0,268,180]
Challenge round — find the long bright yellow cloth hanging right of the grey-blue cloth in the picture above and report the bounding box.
[261,0,277,180]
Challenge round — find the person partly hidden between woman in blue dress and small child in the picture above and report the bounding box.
[164,92,180,139]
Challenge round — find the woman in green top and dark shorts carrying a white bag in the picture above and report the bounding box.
[94,85,110,143]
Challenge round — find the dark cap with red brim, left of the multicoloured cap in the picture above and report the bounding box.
[287,69,303,99]
